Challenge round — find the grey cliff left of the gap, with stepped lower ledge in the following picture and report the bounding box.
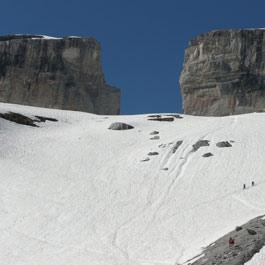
[0,35,120,114]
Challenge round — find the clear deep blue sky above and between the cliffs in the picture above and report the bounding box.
[0,0,265,114]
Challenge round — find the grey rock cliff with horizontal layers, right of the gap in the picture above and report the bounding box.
[180,29,265,116]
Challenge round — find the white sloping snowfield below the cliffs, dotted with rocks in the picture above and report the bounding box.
[0,103,265,265]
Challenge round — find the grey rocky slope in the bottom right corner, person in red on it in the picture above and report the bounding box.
[187,216,265,265]
